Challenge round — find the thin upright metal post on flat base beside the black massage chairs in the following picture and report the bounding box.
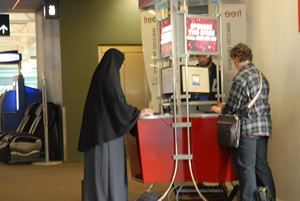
[32,74,63,166]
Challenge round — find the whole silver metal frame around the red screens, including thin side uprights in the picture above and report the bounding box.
[154,0,223,201]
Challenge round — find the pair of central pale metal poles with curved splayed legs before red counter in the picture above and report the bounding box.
[158,0,219,201]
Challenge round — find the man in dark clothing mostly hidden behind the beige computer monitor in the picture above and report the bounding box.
[197,55,218,100]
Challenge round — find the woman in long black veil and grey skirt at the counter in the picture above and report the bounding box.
[78,49,153,201]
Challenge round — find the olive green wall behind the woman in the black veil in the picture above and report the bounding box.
[59,0,141,161]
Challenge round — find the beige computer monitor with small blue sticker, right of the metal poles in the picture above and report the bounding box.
[181,66,210,95]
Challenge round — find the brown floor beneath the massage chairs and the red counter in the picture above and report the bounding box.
[0,159,239,201]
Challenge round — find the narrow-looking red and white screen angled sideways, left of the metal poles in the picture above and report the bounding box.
[159,18,172,58]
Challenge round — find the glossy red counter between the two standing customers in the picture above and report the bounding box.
[128,116,237,183]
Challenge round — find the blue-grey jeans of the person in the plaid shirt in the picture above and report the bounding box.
[233,136,276,201]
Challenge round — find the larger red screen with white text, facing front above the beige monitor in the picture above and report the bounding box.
[186,15,219,55]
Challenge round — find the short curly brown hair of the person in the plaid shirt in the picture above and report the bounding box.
[230,43,253,62]
